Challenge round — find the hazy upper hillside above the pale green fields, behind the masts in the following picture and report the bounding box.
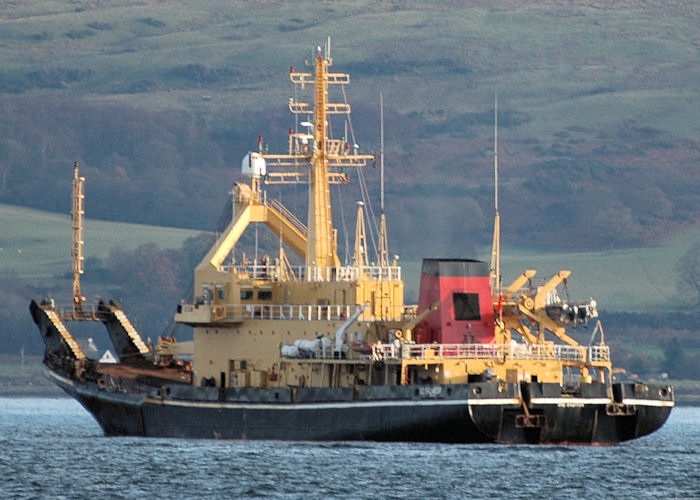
[0,0,700,259]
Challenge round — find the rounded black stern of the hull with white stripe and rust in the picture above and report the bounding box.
[468,382,674,445]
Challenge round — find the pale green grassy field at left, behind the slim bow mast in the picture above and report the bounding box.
[0,204,198,280]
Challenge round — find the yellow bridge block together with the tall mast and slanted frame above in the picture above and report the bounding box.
[175,45,407,328]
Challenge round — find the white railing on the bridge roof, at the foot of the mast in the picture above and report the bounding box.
[222,262,401,282]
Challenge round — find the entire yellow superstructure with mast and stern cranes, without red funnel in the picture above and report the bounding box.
[172,44,611,387]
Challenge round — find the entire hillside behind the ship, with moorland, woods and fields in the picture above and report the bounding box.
[0,0,700,373]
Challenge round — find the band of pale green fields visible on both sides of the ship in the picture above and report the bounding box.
[0,204,700,312]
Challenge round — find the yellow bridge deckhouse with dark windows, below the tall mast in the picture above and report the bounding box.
[175,258,404,326]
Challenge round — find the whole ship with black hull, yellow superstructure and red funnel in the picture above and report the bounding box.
[29,44,674,445]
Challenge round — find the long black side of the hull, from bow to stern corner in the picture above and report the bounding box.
[50,374,492,443]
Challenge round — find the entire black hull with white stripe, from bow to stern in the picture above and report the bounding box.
[49,372,673,444]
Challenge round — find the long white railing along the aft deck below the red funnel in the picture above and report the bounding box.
[372,344,610,362]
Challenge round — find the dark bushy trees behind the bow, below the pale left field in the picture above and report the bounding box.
[0,233,213,354]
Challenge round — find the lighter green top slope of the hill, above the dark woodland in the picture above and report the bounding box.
[0,0,700,138]
